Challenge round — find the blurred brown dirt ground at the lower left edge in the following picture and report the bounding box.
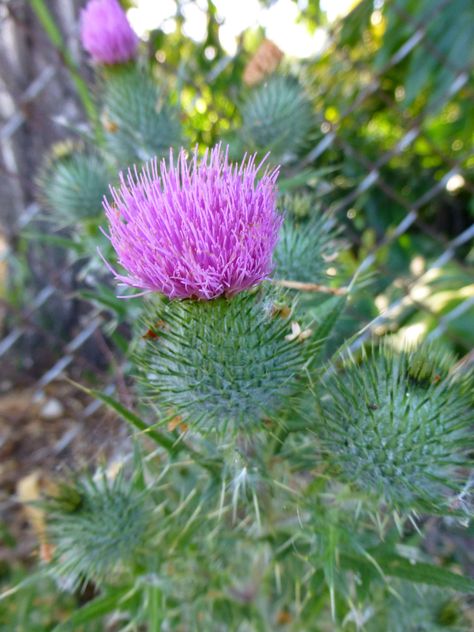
[0,381,128,564]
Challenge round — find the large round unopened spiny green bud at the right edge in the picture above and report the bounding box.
[317,345,473,510]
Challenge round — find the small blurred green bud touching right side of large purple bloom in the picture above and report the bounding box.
[275,196,337,283]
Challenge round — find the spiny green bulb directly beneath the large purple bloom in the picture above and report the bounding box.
[138,293,303,432]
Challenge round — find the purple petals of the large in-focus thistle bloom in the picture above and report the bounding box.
[104,144,283,300]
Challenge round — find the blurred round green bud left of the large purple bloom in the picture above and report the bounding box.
[39,152,111,223]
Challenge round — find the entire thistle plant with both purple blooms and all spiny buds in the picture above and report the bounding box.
[23,0,474,632]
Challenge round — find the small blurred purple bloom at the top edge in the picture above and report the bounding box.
[81,0,138,64]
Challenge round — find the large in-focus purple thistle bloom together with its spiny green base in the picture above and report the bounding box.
[105,146,312,431]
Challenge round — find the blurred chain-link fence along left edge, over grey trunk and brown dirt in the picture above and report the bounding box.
[0,0,126,524]
